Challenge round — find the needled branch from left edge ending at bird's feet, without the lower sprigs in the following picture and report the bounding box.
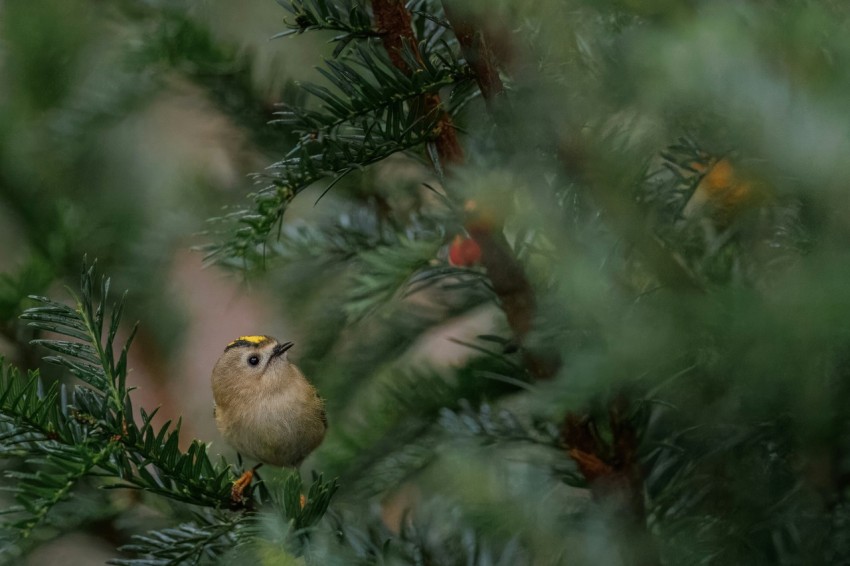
[0,265,242,536]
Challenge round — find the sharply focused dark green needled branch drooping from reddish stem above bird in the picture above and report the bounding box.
[206,2,471,265]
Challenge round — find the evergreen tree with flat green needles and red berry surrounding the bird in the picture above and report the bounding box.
[0,0,850,565]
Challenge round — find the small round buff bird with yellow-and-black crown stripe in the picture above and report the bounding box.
[211,335,328,501]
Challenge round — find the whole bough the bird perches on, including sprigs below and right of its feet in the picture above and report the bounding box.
[0,264,346,564]
